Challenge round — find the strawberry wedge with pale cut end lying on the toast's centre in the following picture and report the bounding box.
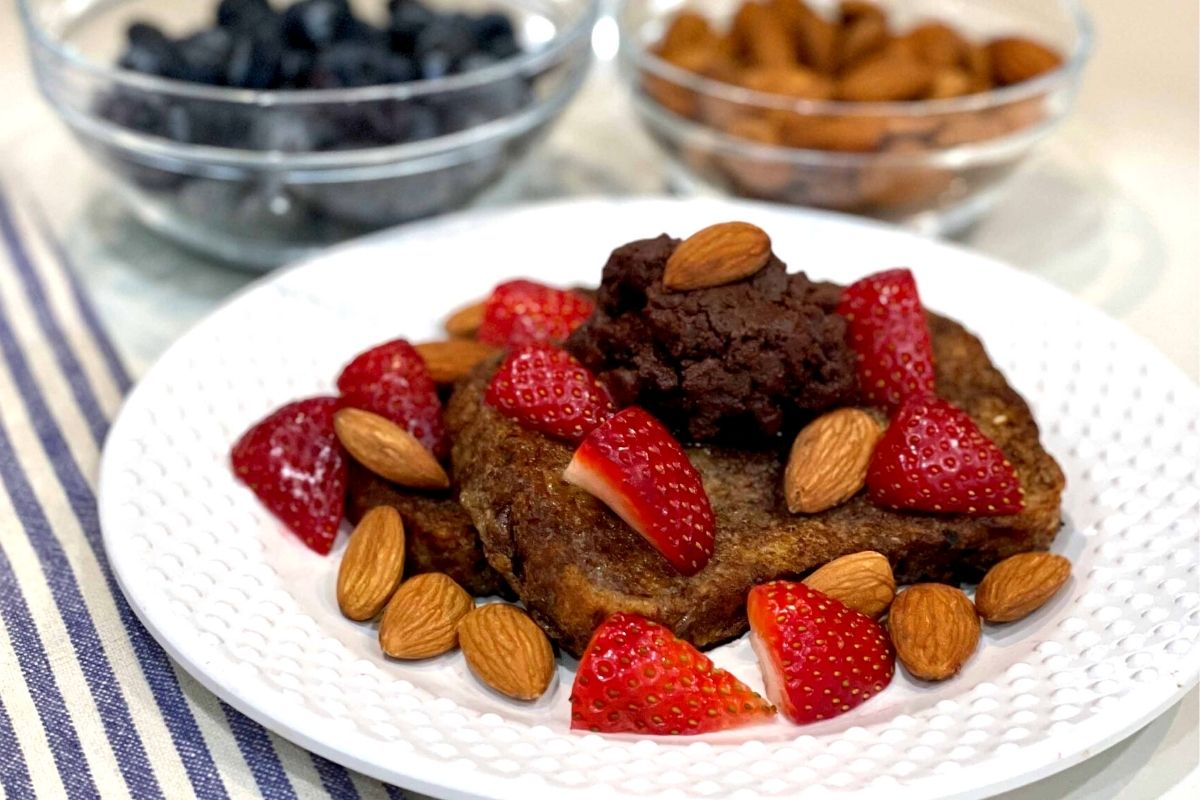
[563,405,716,575]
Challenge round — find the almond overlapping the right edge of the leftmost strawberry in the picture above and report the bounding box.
[334,408,450,489]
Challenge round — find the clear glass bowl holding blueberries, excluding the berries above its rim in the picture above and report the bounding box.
[19,0,599,267]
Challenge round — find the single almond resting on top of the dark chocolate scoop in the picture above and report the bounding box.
[662,222,770,291]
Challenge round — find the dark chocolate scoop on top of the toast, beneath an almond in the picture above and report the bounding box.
[566,235,856,446]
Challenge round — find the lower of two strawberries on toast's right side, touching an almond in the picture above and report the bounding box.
[866,397,1025,517]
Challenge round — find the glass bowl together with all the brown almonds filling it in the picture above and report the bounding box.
[619,0,1091,235]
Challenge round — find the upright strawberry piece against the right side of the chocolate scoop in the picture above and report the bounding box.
[838,270,934,408]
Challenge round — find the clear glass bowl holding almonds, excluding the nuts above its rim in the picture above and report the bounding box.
[618,0,1091,235]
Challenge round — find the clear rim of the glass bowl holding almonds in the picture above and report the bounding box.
[624,0,1094,116]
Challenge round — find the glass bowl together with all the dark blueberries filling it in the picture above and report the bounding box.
[19,0,599,267]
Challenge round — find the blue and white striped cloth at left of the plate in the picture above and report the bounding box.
[0,184,417,800]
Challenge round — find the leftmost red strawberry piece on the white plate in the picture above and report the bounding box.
[230,397,346,555]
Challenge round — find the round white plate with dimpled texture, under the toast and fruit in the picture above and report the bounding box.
[100,200,1200,800]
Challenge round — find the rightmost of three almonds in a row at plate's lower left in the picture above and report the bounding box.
[458,603,554,700]
